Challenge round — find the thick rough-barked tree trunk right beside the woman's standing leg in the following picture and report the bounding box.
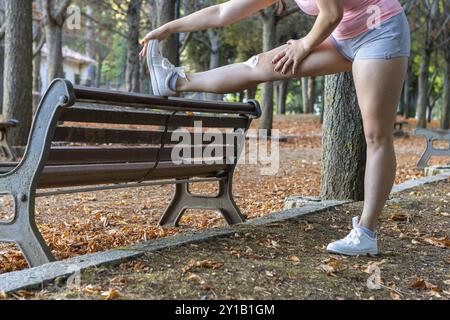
[321,73,366,201]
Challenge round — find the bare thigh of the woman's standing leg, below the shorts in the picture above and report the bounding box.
[353,58,408,136]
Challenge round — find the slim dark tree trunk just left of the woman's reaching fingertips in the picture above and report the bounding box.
[125,0,142,92]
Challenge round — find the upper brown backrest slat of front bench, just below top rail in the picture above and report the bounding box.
[59,105,248,128]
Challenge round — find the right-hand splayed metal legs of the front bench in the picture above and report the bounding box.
[159,174,245,227]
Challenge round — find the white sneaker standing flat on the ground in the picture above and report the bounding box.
[327,217,378,256]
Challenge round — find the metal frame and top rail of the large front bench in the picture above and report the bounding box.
[0,79,261,266]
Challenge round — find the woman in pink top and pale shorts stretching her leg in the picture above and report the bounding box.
[141,0,411,256]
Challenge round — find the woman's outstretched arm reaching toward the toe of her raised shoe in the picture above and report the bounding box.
[141,0,278,51]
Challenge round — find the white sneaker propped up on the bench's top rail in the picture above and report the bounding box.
[147,40,187,97]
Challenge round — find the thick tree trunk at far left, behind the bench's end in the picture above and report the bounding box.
[3,0,33,146]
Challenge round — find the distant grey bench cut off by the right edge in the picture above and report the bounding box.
[414,128,450,168]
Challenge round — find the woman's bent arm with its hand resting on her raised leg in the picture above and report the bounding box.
[272,0,344,74]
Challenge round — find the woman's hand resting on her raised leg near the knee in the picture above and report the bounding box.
[272,40,311,75]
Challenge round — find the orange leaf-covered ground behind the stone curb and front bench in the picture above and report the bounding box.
[0,116,448,273]
